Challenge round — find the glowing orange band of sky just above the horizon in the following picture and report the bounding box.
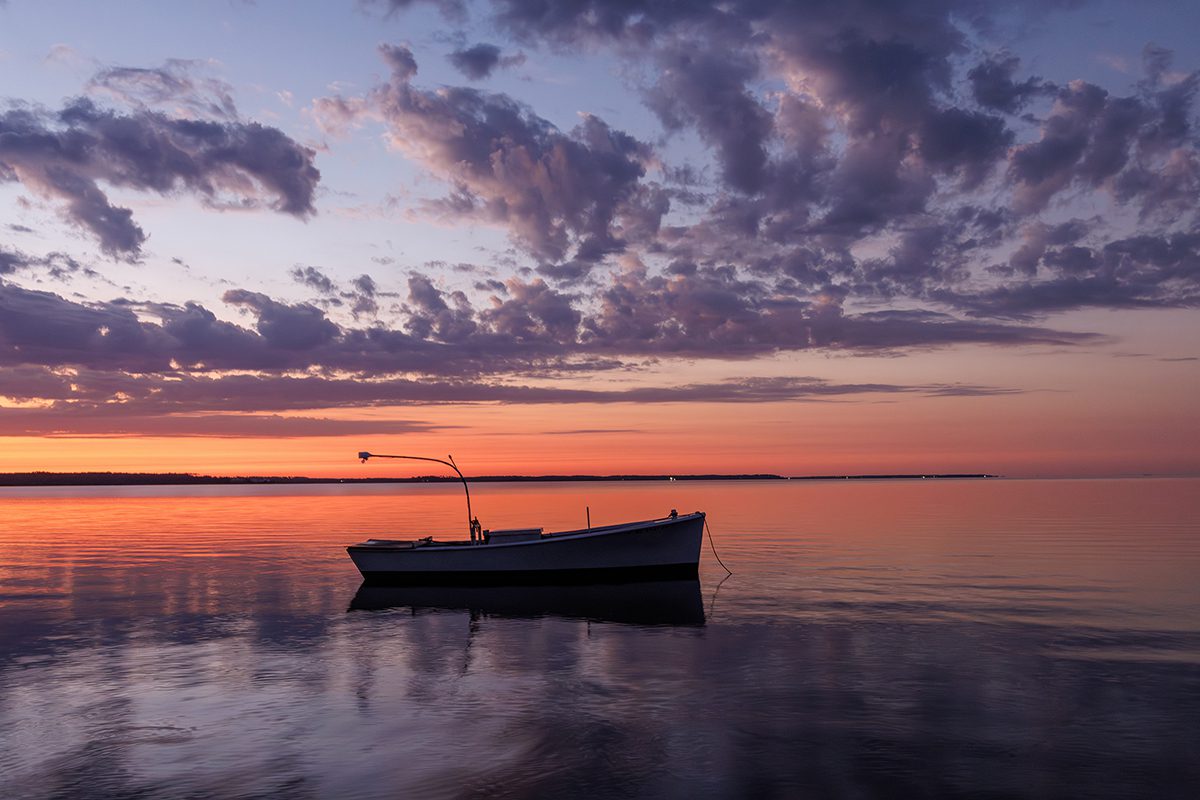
[0,393,1200,477]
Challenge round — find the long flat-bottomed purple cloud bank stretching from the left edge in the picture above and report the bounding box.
[0,266,1099,380]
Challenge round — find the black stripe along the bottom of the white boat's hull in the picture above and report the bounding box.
[352,564,700,587]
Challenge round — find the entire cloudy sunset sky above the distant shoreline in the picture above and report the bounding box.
[0,0,1200,477]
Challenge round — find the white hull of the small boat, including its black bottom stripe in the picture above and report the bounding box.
[346,512,704,584]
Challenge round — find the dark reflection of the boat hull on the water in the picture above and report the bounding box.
[349,578,704,626]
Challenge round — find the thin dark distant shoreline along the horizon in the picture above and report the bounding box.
[0,473,1000,486]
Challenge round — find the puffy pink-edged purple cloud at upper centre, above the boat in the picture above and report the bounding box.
[316,44,661,271]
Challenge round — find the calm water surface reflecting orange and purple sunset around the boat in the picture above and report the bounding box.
[0,480,1200,798]
